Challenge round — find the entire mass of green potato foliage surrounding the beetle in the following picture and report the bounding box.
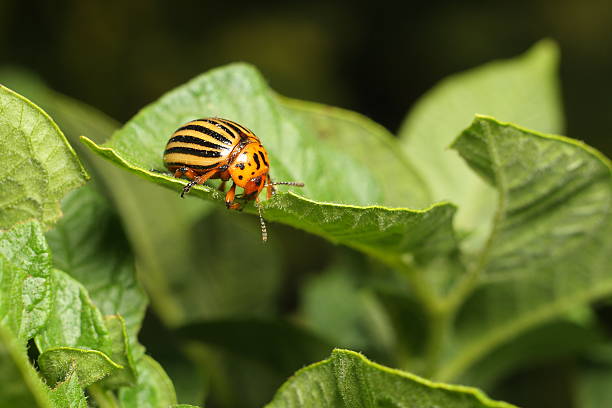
[0,41,612,408]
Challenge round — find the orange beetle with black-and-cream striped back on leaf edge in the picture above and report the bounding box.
[163,117,304,241]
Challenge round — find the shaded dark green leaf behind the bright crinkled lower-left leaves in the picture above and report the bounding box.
[46,186,147,354]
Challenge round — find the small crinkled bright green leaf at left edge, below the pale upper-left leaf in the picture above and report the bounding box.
[0,222,54,344]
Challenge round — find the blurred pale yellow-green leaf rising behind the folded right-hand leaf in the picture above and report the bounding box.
[399,41,563,246]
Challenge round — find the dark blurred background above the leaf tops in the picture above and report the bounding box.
[0,0,612,156]
